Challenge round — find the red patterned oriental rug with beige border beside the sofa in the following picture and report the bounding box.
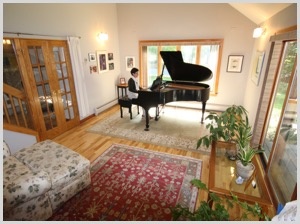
[49,144,202,221]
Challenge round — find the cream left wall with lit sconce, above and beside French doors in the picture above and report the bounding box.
[3,3,120,117]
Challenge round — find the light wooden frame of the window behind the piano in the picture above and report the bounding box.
[139,39,224,96]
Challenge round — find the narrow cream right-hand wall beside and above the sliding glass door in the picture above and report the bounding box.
[244,4,297,125]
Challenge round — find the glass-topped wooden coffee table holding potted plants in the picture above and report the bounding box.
[208,143,274,215]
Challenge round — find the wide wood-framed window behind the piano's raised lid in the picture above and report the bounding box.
[140,39,223,94]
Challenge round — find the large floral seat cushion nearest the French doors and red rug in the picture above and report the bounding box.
[14,140,90,189]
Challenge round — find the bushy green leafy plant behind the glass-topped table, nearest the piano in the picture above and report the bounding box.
[197,105,248,160]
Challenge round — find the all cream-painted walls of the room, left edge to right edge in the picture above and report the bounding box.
[3,3,297,125]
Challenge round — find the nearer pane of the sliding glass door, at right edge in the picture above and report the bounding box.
[268,72,297,204]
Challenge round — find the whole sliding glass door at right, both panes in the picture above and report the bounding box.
[262,41,297,204]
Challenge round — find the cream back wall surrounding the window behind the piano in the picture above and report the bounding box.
[117,3,256,107]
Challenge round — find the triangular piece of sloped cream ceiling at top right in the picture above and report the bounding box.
[229,3,291,25]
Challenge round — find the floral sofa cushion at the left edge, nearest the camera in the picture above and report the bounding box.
[3,156,51,211]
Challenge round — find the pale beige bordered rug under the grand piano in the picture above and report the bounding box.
[87,106,209,152]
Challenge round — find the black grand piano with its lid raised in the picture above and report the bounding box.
[135,51,212,131]
